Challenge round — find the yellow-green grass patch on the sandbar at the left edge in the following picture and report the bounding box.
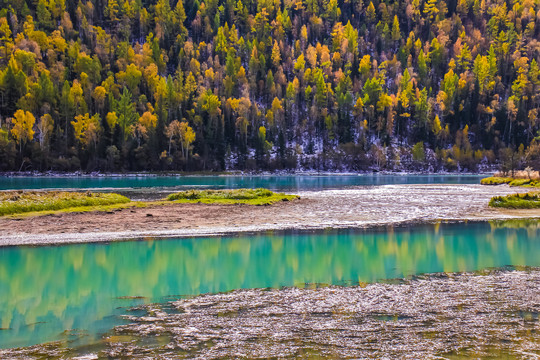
[0,191,131,216]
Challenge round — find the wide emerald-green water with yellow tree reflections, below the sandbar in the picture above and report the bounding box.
[0,222,540,348]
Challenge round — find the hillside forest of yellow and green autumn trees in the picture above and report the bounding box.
[0,0,540,171]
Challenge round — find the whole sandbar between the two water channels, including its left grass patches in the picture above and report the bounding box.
[0,180,540,246]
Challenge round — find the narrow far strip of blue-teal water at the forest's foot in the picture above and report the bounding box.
[0,175,485,191]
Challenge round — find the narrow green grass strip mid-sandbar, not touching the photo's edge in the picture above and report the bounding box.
[167,189,299,205]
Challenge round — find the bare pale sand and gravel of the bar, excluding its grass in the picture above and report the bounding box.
[0,185,540,246]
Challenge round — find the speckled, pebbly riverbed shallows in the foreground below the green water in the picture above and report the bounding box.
[0,268,540,359]
